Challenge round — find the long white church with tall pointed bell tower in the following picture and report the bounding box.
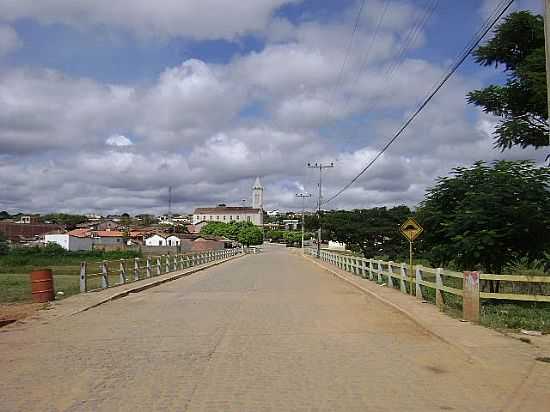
[193,177,264,226]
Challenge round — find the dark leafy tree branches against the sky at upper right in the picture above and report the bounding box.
[468,11,548,150]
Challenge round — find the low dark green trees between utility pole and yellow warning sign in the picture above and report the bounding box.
[321,206,411,259]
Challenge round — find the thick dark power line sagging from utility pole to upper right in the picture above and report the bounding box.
[324,0,514,204]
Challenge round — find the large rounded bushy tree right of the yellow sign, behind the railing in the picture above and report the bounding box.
[418,161,550,273]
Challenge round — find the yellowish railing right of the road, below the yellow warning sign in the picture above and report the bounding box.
[304,248,550,321]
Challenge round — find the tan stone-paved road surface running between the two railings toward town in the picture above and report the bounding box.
[0,246,550,411]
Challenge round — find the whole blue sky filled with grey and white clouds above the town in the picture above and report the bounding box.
[0,0,545,213]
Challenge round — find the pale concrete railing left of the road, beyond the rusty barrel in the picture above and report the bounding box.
[80,248,245,293]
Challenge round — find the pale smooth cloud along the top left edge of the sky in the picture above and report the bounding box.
[0,0,295,40]
